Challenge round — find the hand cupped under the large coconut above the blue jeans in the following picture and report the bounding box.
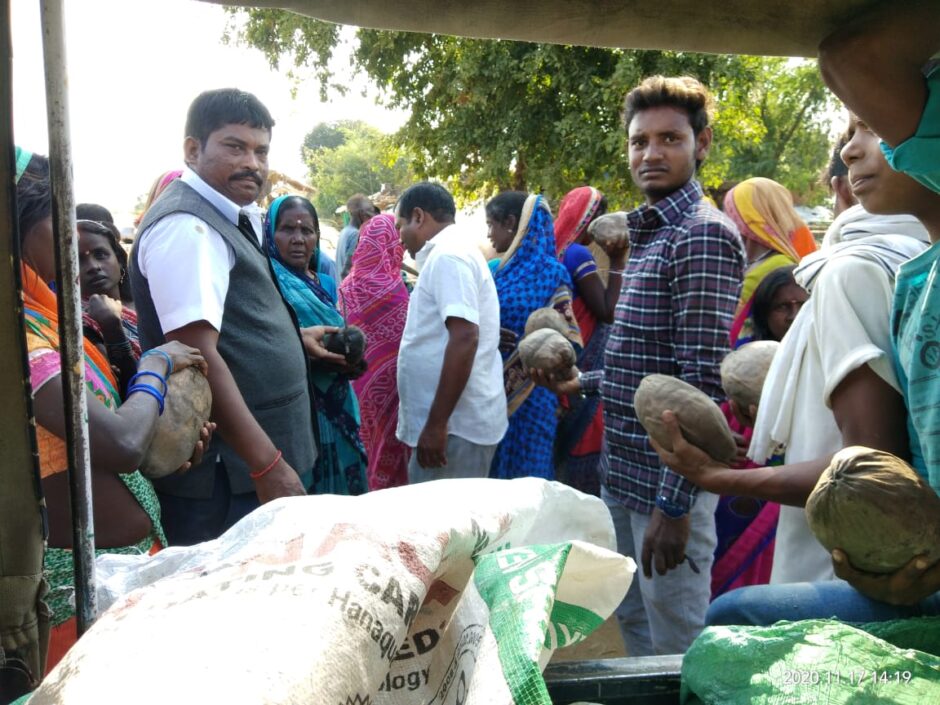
[832,548,940,605]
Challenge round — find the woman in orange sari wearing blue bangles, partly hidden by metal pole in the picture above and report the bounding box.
[17,179,211,672]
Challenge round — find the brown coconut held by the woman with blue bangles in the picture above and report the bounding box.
[140,367,212,478]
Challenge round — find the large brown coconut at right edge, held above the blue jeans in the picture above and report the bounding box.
[806,446,940,573]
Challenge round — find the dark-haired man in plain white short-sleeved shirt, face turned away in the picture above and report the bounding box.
[396,182,508,482]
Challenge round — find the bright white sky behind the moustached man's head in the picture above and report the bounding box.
[12,0,405,224]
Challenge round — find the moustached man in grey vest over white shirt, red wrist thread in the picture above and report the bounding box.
[130,89,342,545]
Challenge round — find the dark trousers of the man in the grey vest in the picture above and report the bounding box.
[157,460,261,546]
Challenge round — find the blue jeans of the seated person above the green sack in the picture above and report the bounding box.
[705,580,940,627]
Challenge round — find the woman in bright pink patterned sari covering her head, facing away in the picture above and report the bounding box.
[339,214,409,490]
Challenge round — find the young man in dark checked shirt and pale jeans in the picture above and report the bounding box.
[533,76,745,656]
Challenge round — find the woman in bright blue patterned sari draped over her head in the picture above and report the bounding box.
[486,191,581,479]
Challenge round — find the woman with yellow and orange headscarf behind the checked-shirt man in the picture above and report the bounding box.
[724,177,817,348]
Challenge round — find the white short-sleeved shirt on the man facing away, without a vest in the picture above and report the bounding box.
[397,225,509,448]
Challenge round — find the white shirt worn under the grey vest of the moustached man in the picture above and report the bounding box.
[137,168,264,333]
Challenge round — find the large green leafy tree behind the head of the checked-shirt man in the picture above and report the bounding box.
[233,10,831,206]
